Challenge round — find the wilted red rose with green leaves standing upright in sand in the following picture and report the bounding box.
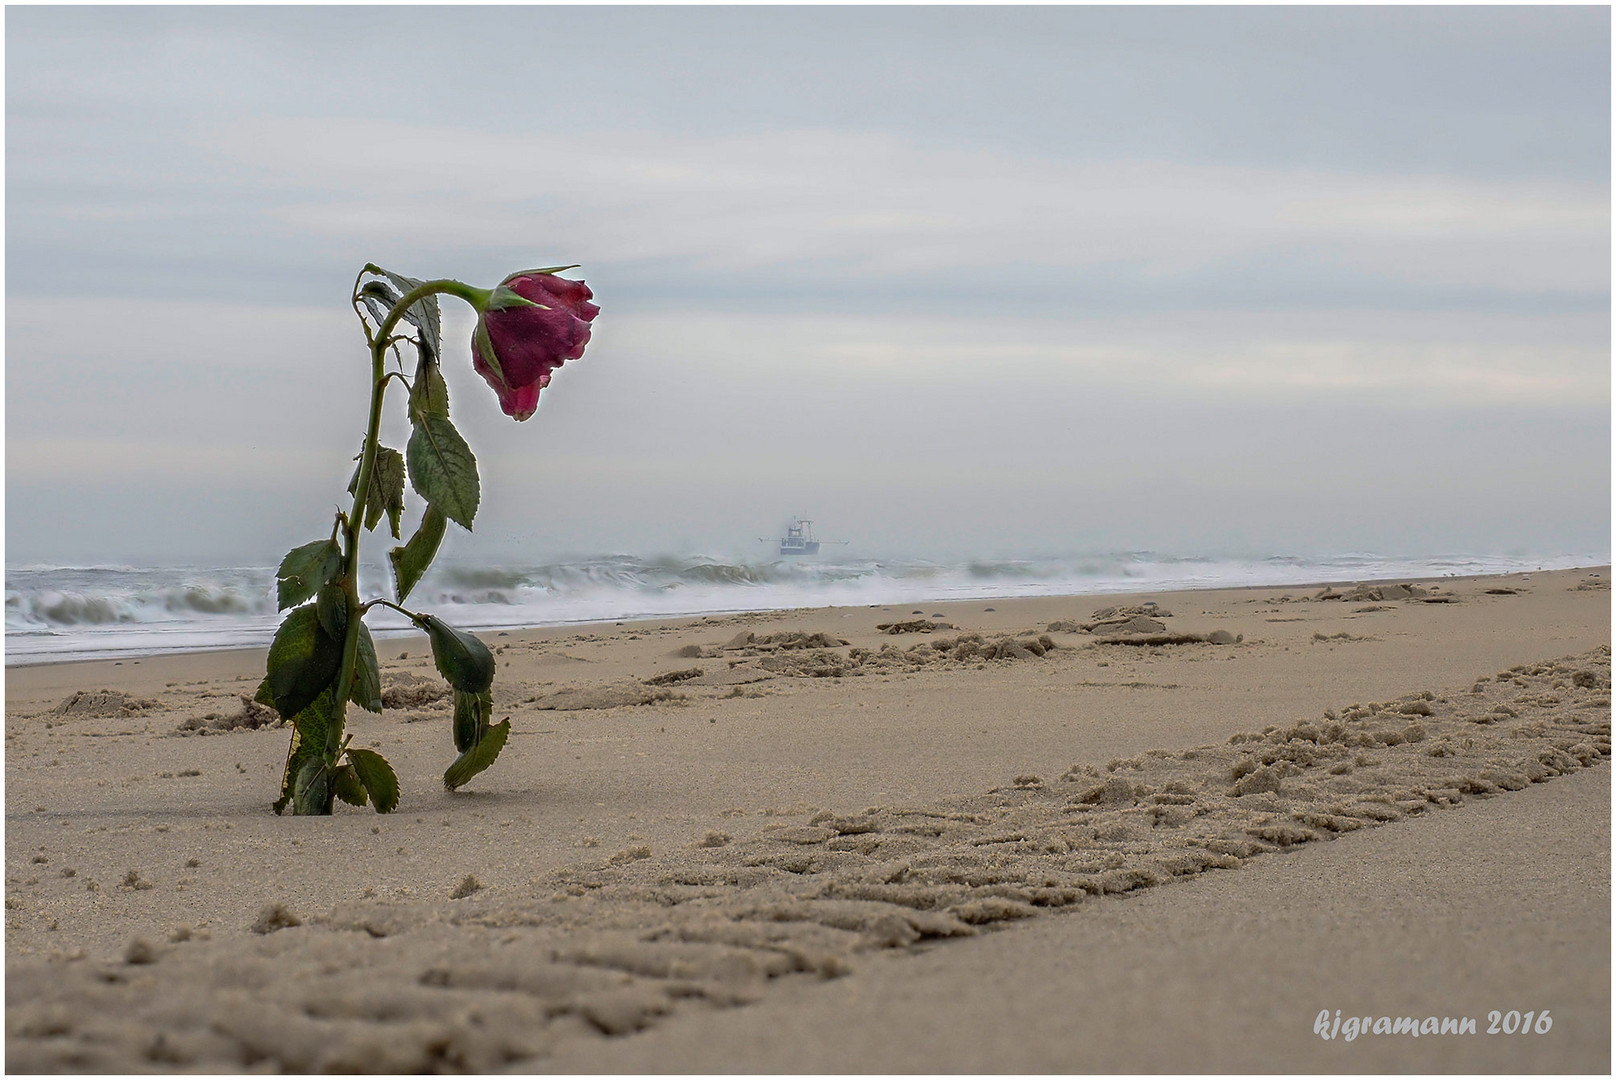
[265,262,600,815]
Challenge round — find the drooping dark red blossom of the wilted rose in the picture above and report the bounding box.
[472,267,600,420]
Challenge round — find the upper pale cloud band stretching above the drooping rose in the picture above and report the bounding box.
[205,118,1610,293]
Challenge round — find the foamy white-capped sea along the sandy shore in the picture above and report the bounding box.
[5,551,1610,666]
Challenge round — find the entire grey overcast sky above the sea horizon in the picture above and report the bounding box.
[5,6,1611,566]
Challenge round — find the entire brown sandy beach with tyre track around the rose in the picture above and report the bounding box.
[5,567,1611,1072]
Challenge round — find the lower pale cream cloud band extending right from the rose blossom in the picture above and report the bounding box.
[584,312,1610,407]
